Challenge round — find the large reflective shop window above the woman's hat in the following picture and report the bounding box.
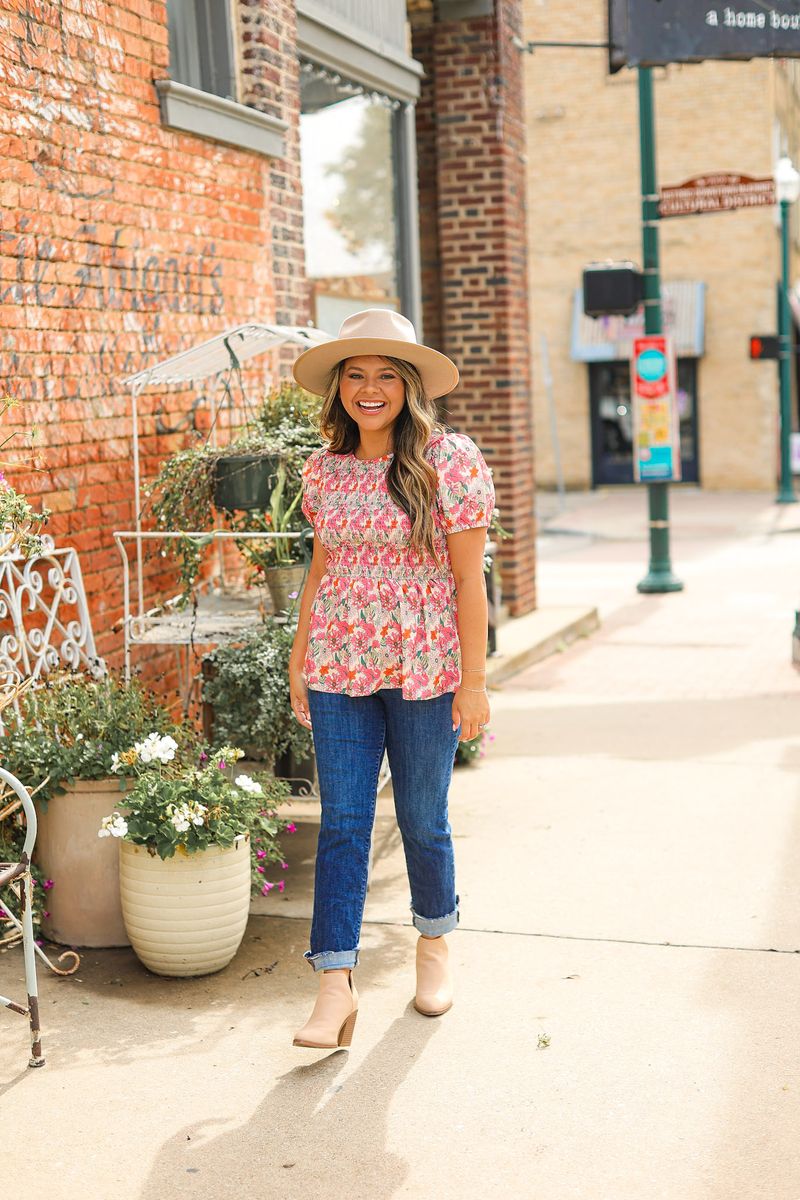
[300,62,404,334]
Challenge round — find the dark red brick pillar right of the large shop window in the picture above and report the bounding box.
[411,0,535,616]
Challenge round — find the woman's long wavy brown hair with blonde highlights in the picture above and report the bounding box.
[319,355,445,562]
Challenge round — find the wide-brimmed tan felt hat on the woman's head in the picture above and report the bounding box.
[294,308,458,400]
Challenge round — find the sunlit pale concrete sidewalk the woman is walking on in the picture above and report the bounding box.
[0,488,800,1200]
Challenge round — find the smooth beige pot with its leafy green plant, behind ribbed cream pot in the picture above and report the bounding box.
[0,672,186,947]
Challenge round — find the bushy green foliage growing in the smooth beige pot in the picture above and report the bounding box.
[0,672,183,804]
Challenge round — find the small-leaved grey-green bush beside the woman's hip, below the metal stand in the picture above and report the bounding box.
[203,622,312,760]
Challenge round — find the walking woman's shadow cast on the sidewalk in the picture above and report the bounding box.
[140,1004,438,1200]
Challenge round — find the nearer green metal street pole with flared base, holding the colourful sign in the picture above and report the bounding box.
[637,67,684,592]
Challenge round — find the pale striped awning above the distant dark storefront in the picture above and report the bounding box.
[571,280,705,362]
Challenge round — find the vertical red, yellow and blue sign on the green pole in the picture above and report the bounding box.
[631,334,681,484]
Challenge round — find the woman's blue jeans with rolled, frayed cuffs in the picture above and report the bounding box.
[305,688,461,971]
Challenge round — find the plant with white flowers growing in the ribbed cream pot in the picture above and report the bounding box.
[98,731,294,892]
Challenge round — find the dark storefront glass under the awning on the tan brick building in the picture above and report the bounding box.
[589,359,699,487]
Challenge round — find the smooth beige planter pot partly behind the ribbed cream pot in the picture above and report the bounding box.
[35,779,130,947]
